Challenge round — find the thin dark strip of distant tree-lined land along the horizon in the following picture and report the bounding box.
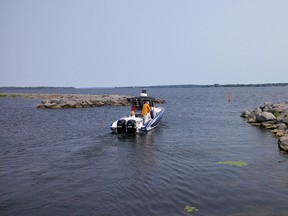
[0,83,288,90]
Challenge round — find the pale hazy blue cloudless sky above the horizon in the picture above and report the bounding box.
[0,0,288,88]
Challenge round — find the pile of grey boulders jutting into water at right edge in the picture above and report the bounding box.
[241,102,288,151]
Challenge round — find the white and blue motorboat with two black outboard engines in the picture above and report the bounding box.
[110,89,165,134]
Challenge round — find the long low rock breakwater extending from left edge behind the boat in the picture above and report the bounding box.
[0,93,165,109]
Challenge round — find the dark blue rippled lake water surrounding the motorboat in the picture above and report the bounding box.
[0,87,288,216]
